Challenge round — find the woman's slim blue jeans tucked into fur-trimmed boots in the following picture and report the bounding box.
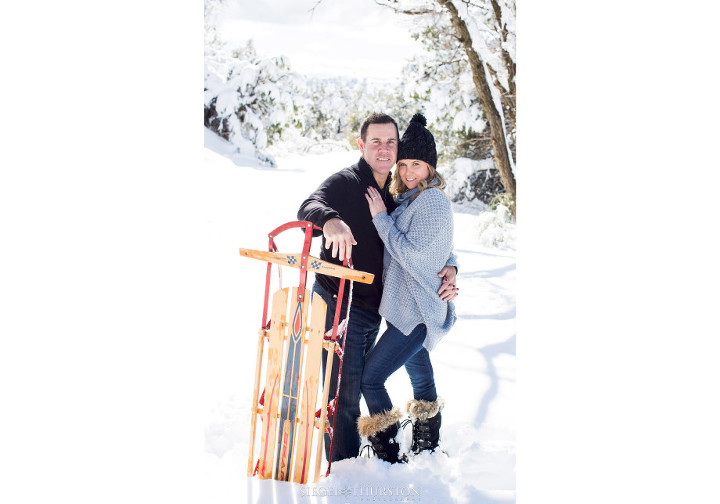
[362,319,437,415]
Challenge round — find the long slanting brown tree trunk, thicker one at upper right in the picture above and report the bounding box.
[436,0,515,201]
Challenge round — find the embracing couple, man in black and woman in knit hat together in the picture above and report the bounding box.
[298,114,458,463]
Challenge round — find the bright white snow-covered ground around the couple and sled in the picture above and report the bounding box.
[204,131,516,504]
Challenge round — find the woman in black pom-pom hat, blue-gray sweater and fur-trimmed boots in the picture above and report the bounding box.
[358,114,457,463]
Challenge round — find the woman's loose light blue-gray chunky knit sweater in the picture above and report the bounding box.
[373,188,457,351]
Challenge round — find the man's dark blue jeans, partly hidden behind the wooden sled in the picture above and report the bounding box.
[313,283,380,462]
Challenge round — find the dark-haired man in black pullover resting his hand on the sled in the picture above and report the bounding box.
[297,113,457,461]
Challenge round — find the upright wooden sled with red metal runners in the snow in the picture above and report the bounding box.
[240,221,374,483]
